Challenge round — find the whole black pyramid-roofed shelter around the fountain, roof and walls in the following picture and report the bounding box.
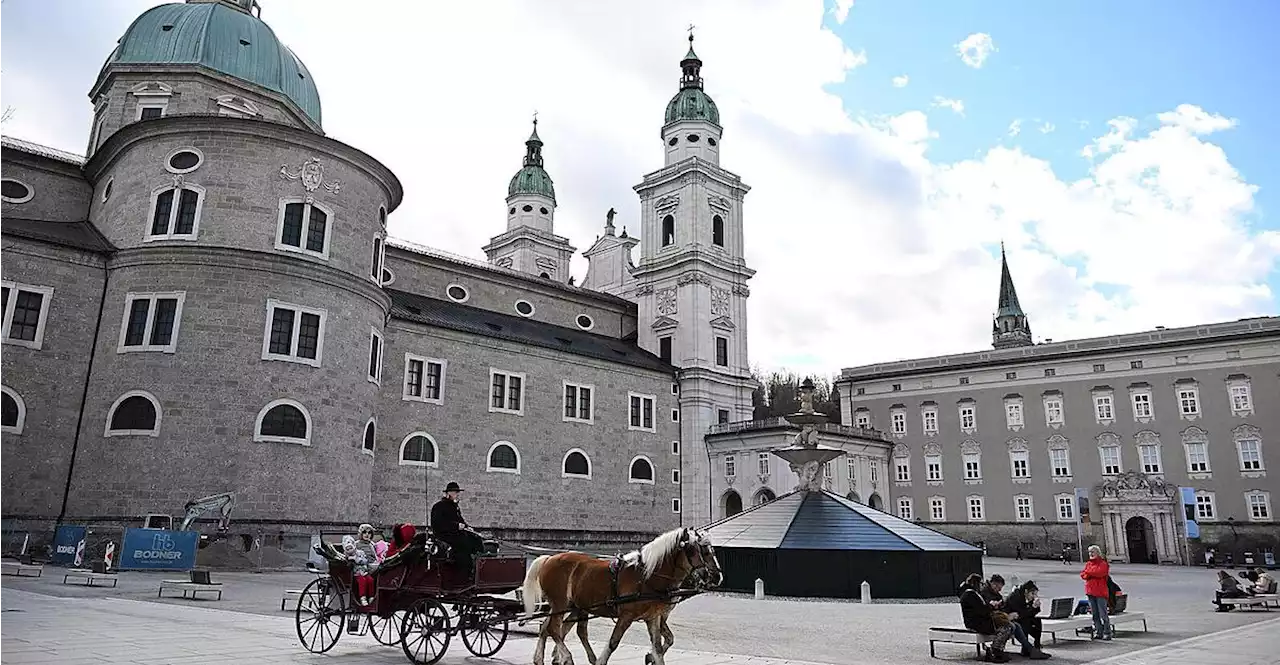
[705,490,982,599]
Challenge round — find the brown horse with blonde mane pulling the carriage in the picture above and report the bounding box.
[524,528,723,665]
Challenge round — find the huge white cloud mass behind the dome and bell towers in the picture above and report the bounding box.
[0,0,1280,373]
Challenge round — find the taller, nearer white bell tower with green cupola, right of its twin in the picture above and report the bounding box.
[627,35,755,526]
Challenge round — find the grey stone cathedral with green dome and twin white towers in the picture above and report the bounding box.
[0,0,754,545]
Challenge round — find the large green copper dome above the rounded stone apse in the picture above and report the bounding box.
[100,0,320,124]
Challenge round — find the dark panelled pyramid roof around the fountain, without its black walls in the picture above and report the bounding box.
[708,491,978,551]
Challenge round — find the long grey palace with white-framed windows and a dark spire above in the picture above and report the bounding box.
[837,250,1280,564]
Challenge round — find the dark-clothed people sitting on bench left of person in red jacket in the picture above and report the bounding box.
[960,573,1050,662]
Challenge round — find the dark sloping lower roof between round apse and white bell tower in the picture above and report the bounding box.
[387,289,676,375]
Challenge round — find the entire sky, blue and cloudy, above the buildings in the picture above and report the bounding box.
[0,0,1280,376]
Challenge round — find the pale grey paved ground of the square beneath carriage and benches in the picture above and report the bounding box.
[0,559,1280,665]
